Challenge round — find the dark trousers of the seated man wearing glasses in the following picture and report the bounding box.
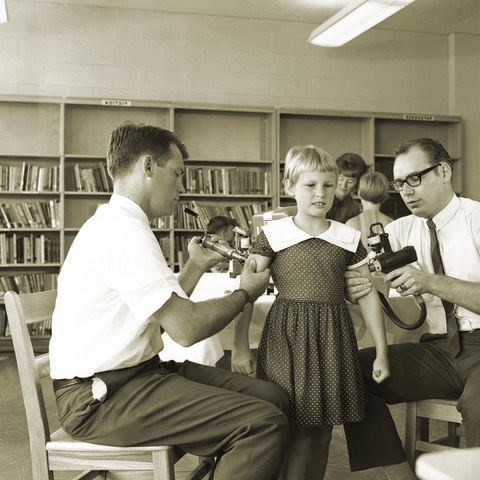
[344,331,480,471]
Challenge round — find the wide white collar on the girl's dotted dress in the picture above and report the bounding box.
[262,217,361,253]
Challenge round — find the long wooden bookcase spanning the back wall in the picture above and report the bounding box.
[0,96,462,351]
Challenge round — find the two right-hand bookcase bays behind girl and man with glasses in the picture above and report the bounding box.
[278,110,462,218]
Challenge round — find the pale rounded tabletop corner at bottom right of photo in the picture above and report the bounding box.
[415,447,480,480]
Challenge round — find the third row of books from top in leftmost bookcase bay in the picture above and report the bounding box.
[0,233,60,265]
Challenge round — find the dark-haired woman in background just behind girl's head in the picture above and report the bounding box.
[327,153,368,223]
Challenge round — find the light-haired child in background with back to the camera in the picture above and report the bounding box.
[346,172,393,252]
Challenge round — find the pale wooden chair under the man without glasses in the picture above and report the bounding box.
[5,290,211,480]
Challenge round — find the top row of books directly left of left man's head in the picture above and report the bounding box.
[65,162,113,192]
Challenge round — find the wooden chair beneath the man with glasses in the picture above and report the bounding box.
[405,399,462,468]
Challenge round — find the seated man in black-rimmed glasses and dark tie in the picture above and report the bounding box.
[345,138,480,480]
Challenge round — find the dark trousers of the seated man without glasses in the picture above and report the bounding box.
[56,357,289,480]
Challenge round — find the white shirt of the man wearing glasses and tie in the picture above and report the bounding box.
[385,196,480,333]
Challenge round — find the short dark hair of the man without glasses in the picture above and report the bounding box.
[107,122,188,179]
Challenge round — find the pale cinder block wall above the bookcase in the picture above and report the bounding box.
[0,0,449,114]
